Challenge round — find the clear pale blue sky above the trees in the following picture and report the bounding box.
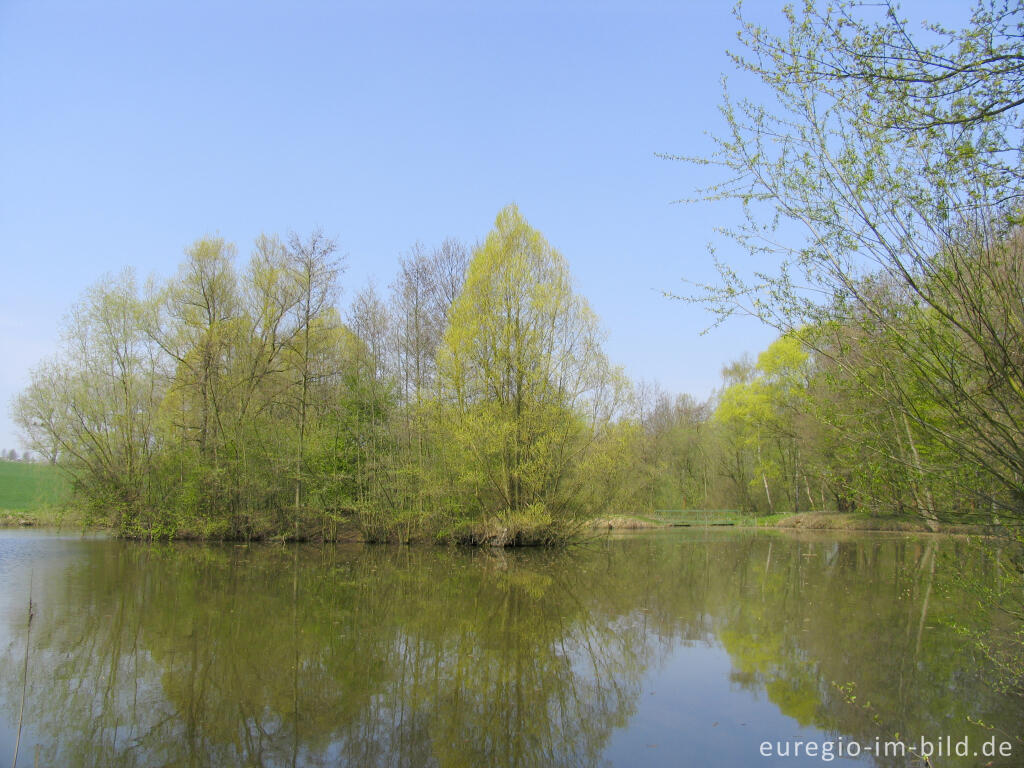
[0,0,958,449]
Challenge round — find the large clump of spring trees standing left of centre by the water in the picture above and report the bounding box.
[15,207,647,543]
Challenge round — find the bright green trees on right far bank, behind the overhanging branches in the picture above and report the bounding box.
[684,325,1021,525]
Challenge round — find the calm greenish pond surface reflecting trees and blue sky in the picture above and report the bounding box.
[0,530,1024,768]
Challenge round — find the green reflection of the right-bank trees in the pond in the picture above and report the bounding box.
[718,538,1024,757]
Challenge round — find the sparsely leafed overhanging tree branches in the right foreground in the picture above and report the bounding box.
[671,2,1024,519]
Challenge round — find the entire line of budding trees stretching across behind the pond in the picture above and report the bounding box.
[14,207,1019,544]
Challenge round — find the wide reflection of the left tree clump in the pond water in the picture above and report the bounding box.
[4,546,651,766]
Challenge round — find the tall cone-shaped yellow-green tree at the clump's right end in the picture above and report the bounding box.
[437,206,624,519]
